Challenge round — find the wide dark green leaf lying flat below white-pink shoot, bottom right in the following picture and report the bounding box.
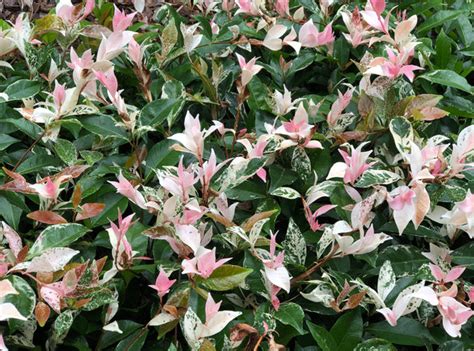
[366,317,434,346]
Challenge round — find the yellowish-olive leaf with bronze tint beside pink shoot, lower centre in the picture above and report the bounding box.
[201,264,253,291]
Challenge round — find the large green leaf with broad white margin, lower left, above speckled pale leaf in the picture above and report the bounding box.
[28,223,89,259]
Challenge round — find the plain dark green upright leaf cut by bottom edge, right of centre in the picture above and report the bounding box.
[330,308,364,351]
